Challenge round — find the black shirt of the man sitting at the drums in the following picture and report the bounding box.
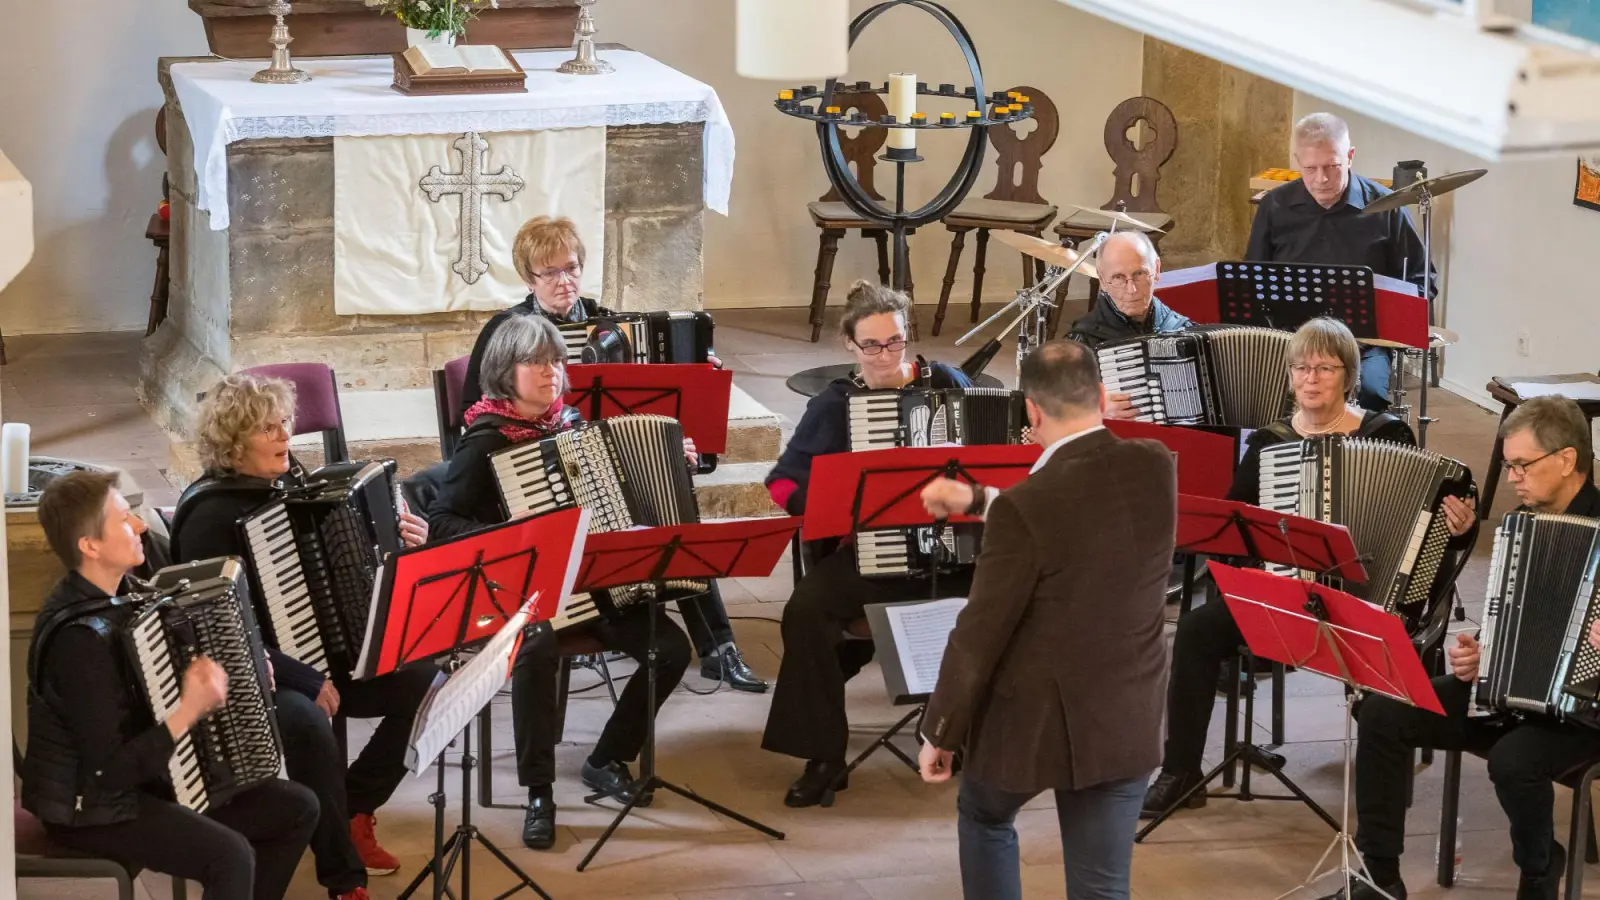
[1245,171,1438,293]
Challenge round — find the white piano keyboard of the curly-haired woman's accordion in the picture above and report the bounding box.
[236,503,330,674]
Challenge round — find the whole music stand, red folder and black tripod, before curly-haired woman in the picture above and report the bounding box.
[360,508,589,900]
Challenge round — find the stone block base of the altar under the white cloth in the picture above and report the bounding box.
[139,58,704,434]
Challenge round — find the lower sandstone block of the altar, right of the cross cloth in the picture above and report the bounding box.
[619,211,706,312]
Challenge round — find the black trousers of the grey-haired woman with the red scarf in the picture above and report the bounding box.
[510,602,690,788]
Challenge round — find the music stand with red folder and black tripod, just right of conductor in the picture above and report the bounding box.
[1134,493,1366,842]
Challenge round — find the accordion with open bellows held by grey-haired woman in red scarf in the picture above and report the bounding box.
[490,415,706,629]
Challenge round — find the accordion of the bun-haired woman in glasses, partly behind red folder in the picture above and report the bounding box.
[850,388,1029,578]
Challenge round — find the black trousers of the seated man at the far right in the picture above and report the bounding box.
[1355,676,1600,874]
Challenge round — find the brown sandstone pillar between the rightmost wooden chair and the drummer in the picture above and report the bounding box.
[1144,37,1294,269]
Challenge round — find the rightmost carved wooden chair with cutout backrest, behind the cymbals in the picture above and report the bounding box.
[1050,96,1178,336]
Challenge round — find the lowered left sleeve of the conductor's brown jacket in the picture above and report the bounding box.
[925,493,1038,749]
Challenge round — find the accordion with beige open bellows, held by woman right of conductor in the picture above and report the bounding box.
[1259,436,1477,636]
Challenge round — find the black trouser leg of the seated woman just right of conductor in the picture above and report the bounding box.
[1162,591,1245,775]
